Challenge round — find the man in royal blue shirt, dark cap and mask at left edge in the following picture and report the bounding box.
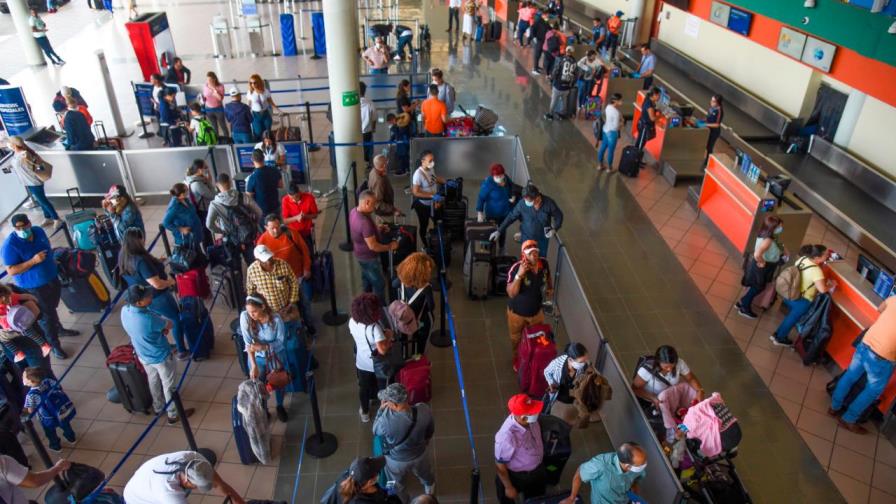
[0,214,80,359]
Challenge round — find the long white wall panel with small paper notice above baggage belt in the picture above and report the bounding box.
[656,4,814,117]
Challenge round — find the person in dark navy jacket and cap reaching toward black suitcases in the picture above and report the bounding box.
[489,184,563,254]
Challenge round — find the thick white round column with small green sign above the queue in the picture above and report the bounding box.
[322,0,364,189]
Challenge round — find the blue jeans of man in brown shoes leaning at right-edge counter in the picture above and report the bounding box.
[831,343,896,423]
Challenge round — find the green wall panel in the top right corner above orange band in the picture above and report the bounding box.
[725,0,896,66]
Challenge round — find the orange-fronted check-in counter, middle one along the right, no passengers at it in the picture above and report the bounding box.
[697,154,812,255]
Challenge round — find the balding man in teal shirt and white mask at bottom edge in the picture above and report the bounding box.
[560,441,647,504]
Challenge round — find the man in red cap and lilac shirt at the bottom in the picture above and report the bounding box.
[495,394,547,504]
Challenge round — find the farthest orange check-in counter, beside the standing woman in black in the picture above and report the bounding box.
[632,91,709,185]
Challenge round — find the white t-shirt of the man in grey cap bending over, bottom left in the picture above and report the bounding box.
[122,451,202,504]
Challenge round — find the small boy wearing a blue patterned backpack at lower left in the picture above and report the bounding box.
[22,367,76,452]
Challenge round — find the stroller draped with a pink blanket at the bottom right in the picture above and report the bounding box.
[679,393,753,504]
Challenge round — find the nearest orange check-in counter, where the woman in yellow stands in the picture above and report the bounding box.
[824,261,896,420]
